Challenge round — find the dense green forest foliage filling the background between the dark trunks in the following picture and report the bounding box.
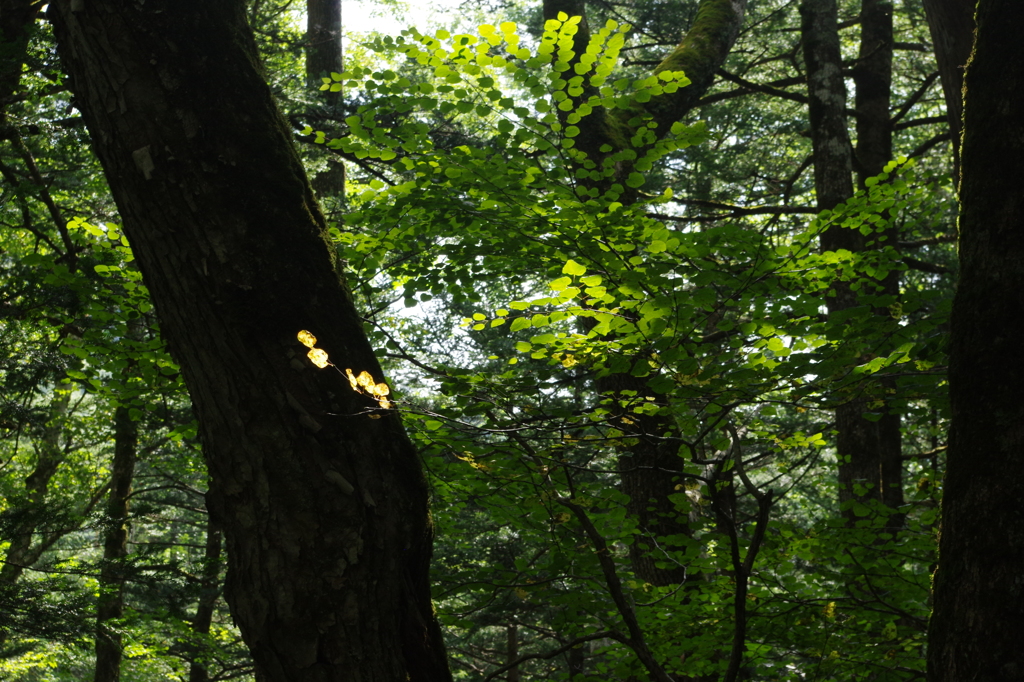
[0,0,954,681]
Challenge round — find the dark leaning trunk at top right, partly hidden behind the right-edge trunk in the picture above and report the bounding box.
[924,0,977,187]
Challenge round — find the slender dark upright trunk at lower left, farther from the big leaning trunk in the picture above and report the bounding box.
[95,406,138,682]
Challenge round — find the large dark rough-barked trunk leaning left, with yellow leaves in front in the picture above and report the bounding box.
[49,0,451,682]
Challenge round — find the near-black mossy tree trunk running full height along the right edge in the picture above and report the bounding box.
[928,0,1024,682]
